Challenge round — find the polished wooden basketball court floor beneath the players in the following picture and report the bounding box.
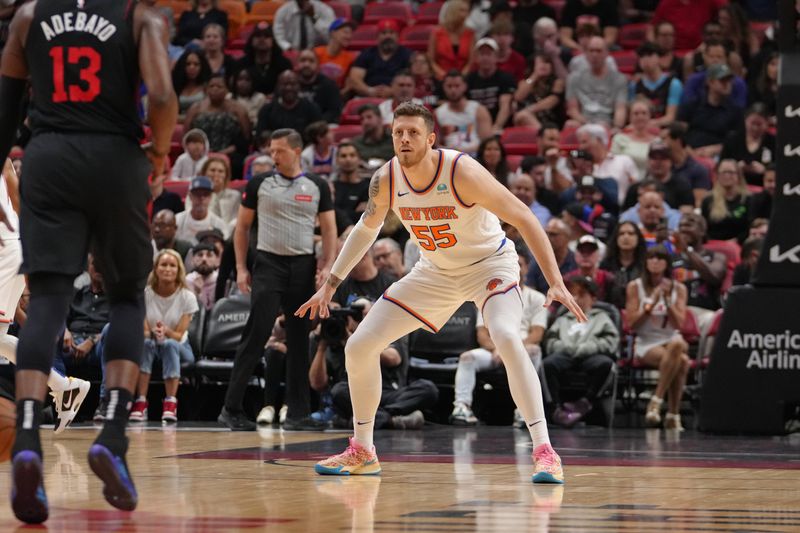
[0,424,800,533]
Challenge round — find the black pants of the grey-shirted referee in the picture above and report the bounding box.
[225,251,317,419]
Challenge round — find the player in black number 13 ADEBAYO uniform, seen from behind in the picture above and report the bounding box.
[0,0,177,523]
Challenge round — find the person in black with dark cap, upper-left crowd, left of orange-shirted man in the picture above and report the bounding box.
[236,22,292,95]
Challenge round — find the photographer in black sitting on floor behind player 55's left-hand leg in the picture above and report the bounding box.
[309,298,439,429]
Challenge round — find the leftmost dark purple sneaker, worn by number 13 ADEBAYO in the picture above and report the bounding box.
[11,450,50,524]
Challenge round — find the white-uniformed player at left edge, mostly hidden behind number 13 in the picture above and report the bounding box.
[0,159,91,433]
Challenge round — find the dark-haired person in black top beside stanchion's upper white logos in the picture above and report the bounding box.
[719,103,775,187]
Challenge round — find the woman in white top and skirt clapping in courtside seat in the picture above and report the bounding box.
[625,245,689,430]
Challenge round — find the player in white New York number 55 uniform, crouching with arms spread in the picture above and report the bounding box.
[296,103,586,483]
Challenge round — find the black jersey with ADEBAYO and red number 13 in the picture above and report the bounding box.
[25,0,142,139]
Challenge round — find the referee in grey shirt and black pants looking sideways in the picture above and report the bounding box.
[218,129,336,431]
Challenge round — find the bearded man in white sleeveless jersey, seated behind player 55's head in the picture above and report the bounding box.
[434,70,492,153]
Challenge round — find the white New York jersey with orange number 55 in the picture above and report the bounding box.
[389,149,506,270]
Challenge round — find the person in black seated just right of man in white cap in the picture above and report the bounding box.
[514,54,565,130]
